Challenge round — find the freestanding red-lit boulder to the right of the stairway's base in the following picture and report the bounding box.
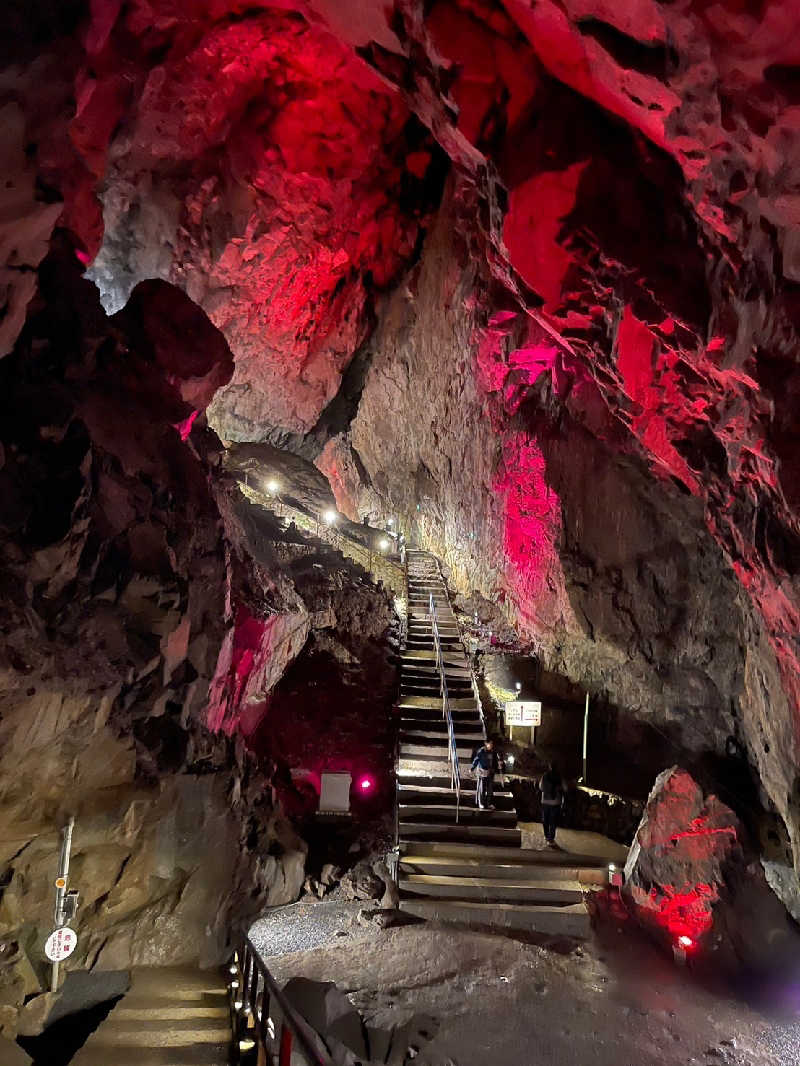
[625,766,742,944]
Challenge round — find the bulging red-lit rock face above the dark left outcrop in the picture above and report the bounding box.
[64,0,445,440]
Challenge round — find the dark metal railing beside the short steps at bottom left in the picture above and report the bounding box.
[229,936,334,1066]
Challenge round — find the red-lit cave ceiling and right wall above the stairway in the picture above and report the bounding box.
[0,0,800,874]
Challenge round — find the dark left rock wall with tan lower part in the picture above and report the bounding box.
[0,244,387,1035]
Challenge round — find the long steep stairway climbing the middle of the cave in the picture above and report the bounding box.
[397,550,592,936]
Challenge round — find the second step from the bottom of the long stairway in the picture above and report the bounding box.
[399,867,583,903]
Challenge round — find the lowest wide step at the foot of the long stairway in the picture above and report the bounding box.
[400,900,591,939]
